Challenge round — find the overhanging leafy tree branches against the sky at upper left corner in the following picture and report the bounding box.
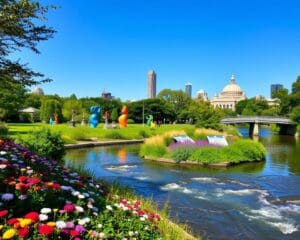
[0,0,55,86]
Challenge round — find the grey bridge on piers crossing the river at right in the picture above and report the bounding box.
[221,116,296,136]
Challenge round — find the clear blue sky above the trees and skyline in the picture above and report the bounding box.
[15,0,300,100]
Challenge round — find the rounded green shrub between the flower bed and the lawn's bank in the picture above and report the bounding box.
[21,128,65,160]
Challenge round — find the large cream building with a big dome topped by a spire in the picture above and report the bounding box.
[211,74,246,111]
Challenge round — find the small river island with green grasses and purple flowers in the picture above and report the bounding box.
[140,129,266,166]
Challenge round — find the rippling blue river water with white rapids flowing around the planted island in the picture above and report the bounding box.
[65,129,300,239]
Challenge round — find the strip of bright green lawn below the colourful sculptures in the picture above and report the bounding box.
[8,123,195,143]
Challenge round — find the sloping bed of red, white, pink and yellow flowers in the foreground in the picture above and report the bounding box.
[0,139,161,240]
